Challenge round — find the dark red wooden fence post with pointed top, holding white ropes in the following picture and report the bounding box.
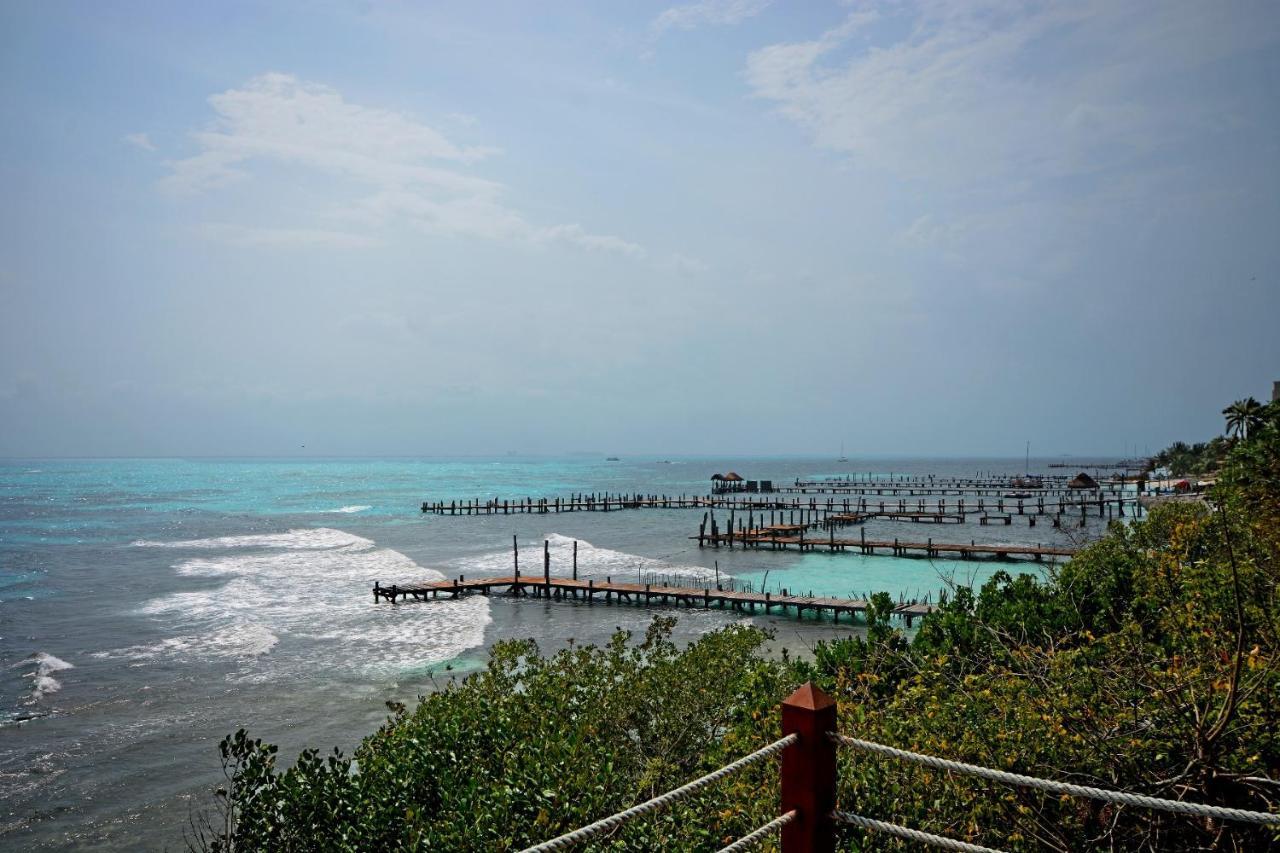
[782,681,836,853]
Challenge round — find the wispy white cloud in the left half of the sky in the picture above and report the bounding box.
[164,73,644,257]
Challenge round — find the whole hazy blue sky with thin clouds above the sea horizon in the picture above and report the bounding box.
[0,0,1280,456]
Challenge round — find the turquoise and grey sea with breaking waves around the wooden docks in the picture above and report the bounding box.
[0,455,1121,849]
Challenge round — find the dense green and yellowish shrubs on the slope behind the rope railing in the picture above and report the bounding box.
[195,406,1280,850]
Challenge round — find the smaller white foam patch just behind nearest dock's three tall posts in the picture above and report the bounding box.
[454,533,730,583]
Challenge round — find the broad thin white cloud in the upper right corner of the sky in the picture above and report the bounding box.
[746,0,1276,186]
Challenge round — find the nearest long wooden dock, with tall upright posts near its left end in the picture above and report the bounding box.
[374,574,934,626]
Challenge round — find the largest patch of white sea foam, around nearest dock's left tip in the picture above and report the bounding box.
[116,528,490,681]
